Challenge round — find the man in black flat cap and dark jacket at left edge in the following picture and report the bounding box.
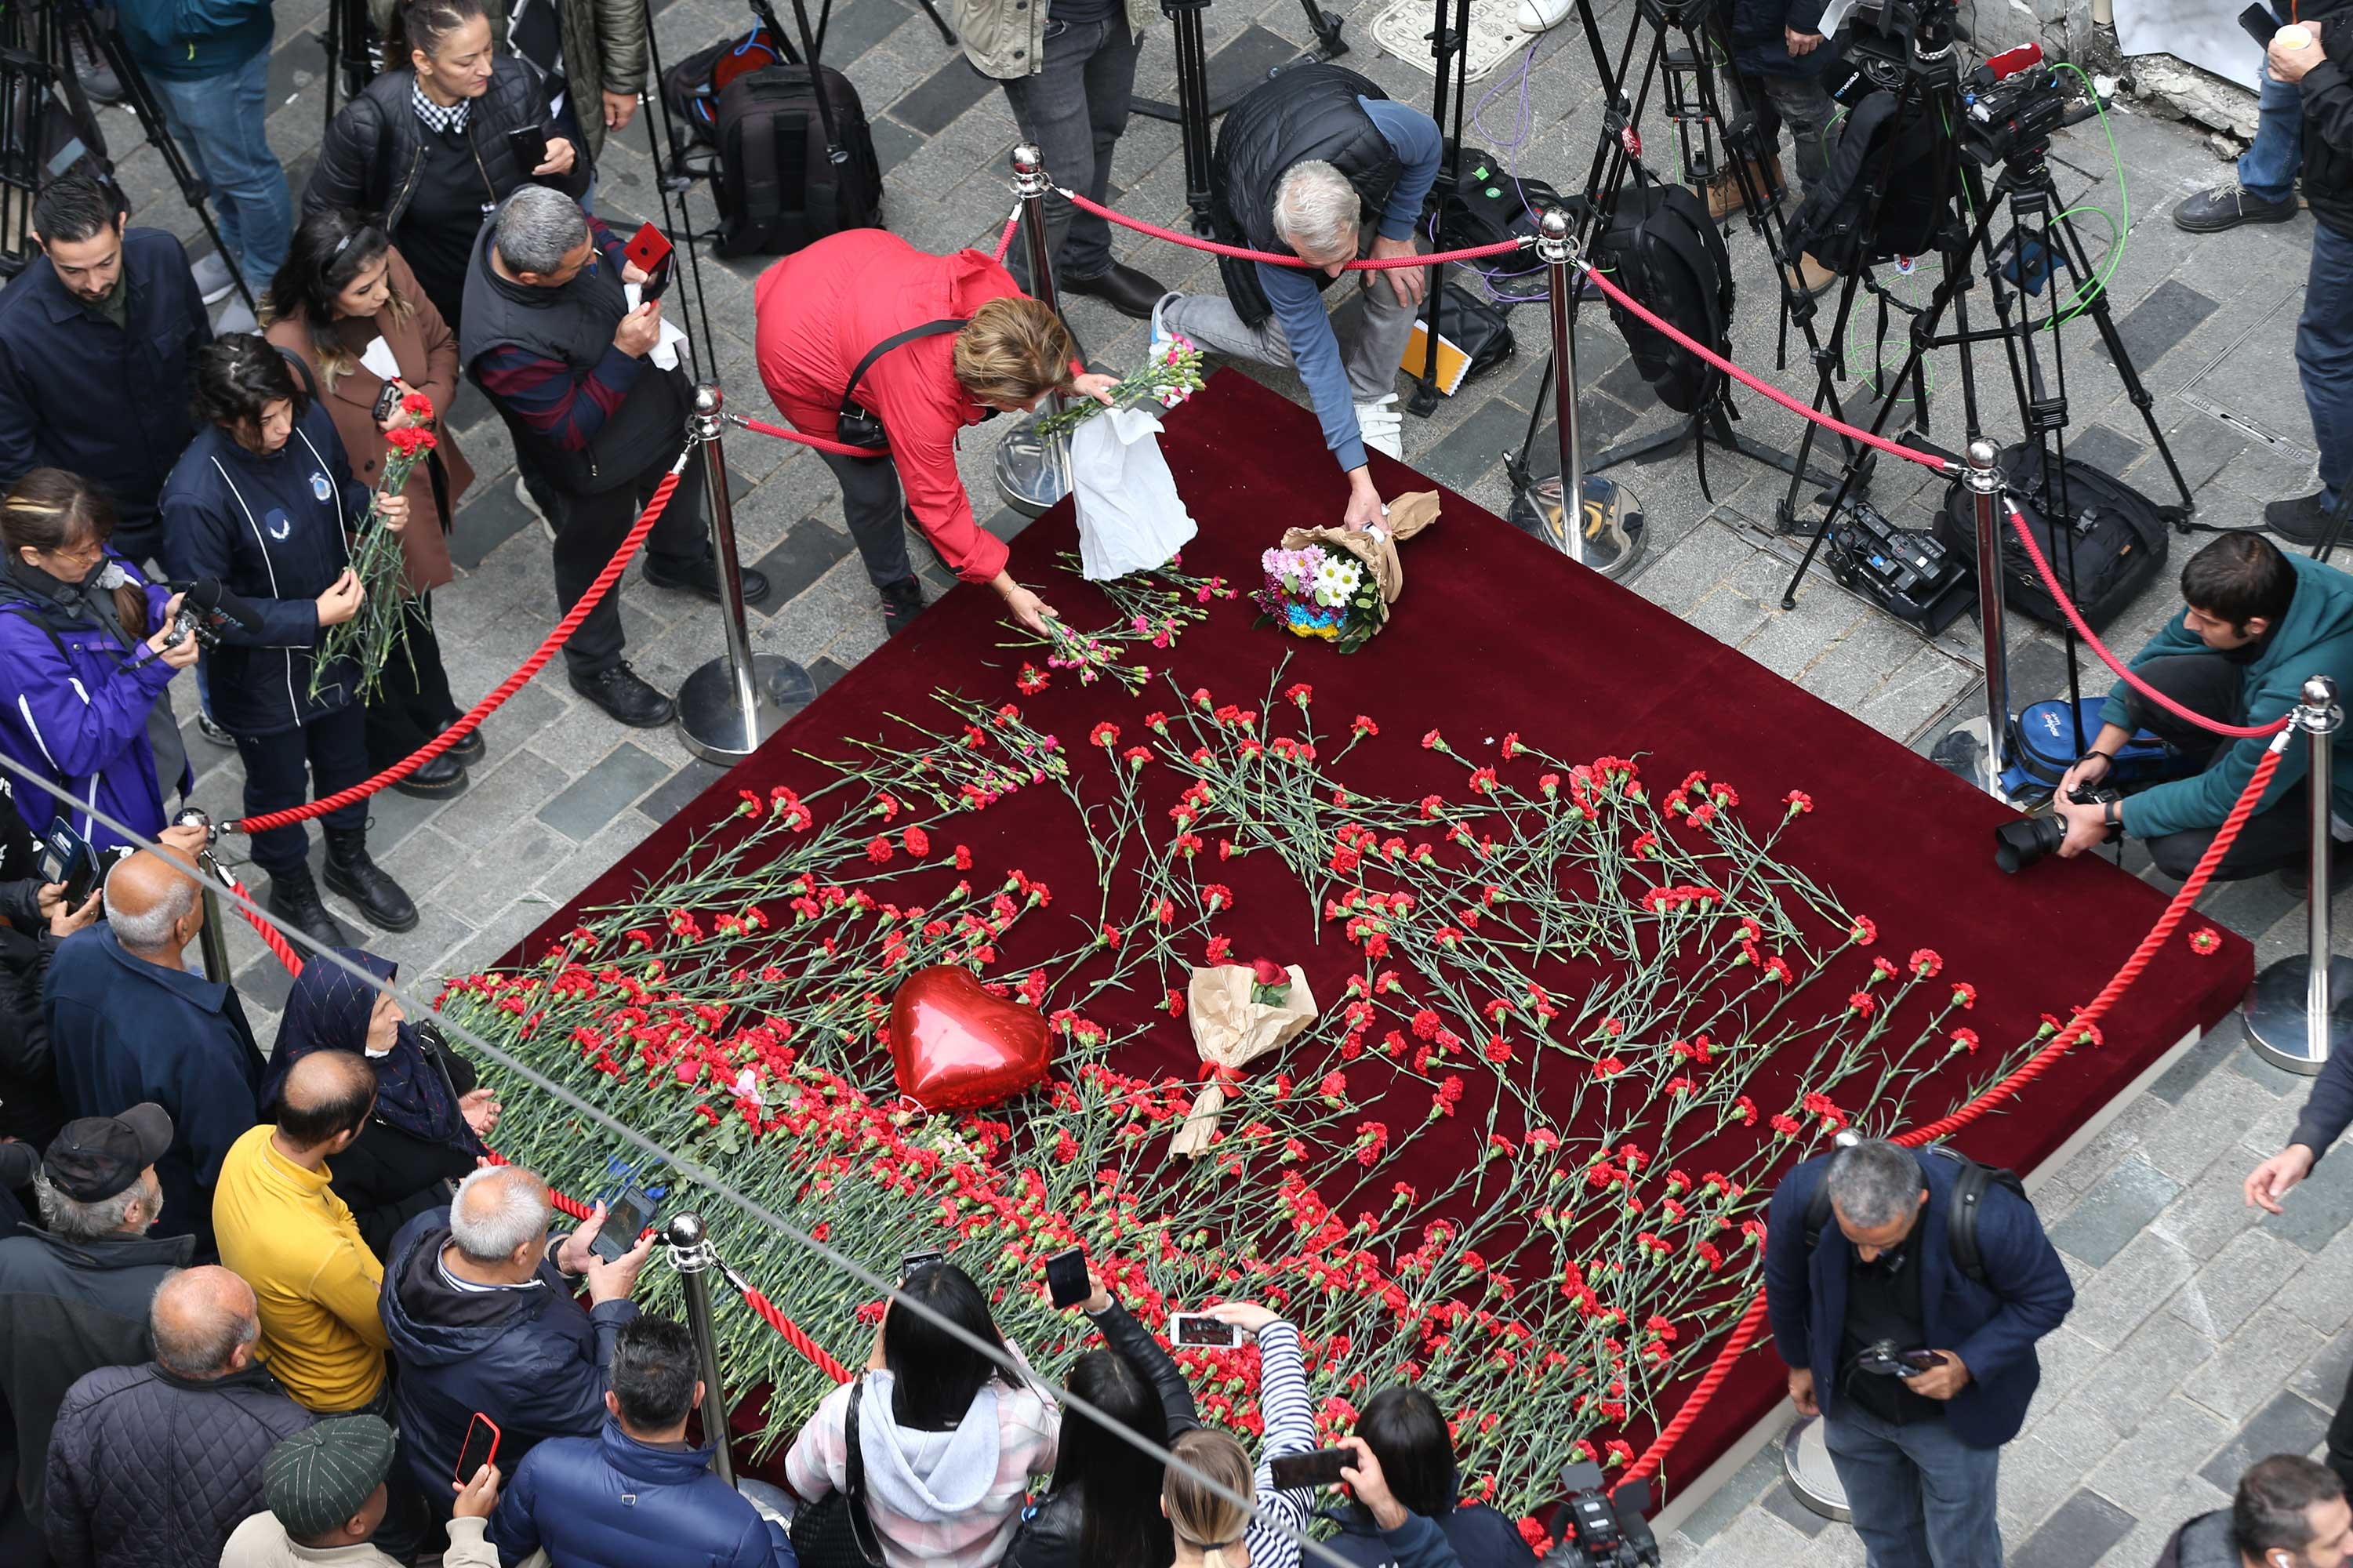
[0,1104,195,1521]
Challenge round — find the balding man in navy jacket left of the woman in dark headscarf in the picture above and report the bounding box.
[42,826,261,1258]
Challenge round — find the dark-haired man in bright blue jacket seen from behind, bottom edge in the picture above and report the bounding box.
[489,1316,797,1568]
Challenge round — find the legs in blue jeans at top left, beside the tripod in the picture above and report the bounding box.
[118,0,294,315]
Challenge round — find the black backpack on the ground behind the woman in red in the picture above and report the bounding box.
[710,66,882,256]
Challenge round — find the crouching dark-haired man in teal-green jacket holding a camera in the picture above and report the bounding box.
[2054,530,2353,892]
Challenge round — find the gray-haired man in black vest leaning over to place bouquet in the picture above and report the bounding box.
[1153,66,1443,528]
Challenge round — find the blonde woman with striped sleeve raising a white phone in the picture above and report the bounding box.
[1160,1302,1462,1568]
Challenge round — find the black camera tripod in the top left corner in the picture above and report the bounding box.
[0,0,254,310]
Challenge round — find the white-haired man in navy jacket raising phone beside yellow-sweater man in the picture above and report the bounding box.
[376,1165,654,1519]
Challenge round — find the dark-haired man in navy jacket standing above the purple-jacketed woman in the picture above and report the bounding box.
[0,174,209,561]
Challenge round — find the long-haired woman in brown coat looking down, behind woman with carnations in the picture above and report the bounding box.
[268,207,482,796]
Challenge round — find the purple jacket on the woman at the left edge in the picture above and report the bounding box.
[0,551,183,850]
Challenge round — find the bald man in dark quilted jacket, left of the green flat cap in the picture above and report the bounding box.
[42,1267,313,1568]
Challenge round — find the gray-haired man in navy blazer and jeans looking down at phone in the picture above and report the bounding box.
[1765,1134,2075,1568]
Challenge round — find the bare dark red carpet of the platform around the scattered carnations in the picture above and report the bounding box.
[510,372,2252,1506]
